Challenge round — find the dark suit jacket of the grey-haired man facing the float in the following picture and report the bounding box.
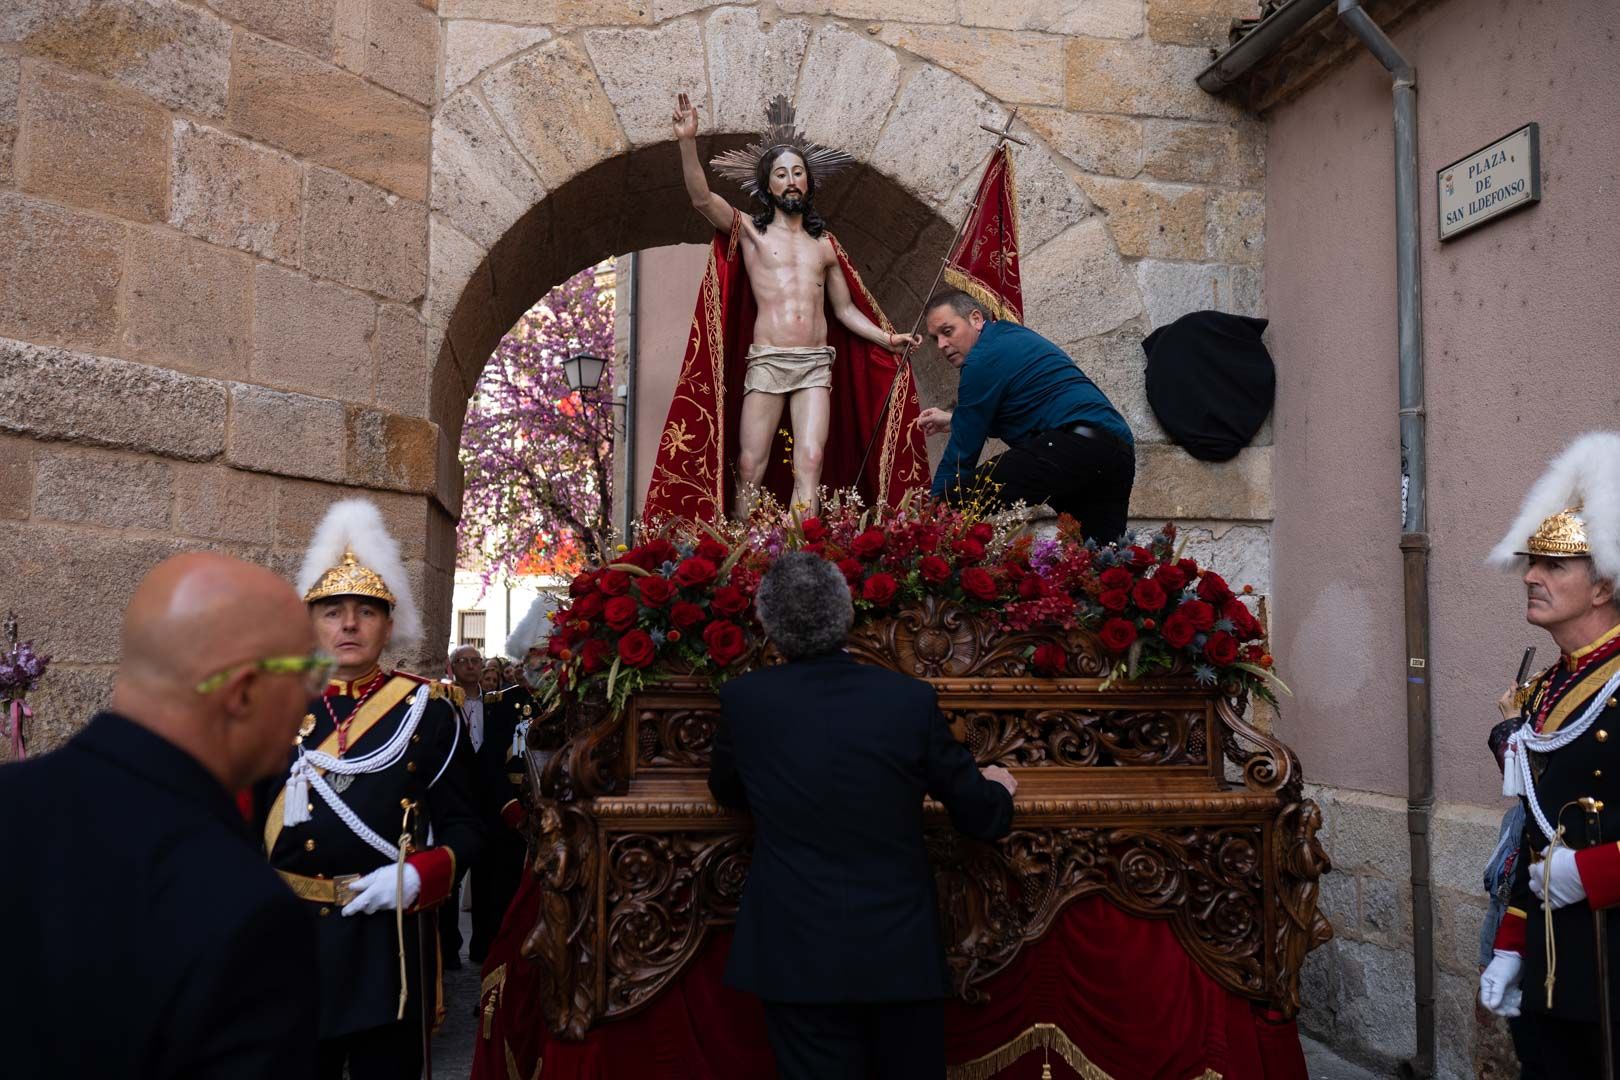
[710,651,1013,1002]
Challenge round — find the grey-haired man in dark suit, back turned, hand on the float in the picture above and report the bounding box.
[710,552,1017,1080]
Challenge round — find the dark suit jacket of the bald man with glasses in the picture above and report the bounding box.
[0,712,319,1080]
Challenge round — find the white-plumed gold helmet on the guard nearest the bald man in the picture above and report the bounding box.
[298,499,421,644]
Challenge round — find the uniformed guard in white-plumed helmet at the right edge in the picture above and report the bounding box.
[1479,432,1620,1078]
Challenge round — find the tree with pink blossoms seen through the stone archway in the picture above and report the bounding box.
[457,267,614,581]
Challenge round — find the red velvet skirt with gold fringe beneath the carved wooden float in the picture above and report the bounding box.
[473,879,1306,1080]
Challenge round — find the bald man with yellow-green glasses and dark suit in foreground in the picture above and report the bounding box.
[0,554,329,1080]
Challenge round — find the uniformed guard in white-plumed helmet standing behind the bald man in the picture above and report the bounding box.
[259,499,484,1080]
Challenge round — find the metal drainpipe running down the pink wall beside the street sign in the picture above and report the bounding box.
[1338,0,1435,1077]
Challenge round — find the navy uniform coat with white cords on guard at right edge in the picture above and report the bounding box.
[1497,646,1620,1023]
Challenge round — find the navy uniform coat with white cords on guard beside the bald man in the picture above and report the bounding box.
[254,672,484,1040]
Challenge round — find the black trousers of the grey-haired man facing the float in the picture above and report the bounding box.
[765,1001,944,1080]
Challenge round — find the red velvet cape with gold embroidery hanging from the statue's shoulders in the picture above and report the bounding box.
[642,214,930,523]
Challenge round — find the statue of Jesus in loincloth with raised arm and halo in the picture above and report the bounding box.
[674,94,920,518]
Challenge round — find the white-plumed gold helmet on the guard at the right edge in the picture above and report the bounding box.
[1490,431,1620,580]
